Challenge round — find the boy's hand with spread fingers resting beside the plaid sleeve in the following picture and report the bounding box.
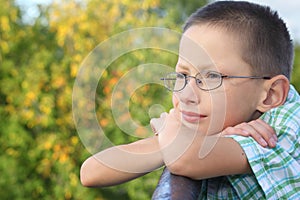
[221,119,277,147]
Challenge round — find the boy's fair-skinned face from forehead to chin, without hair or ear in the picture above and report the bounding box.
[173,25,263,135]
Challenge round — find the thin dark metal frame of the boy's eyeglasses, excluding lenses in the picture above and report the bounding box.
[160,71,272,92]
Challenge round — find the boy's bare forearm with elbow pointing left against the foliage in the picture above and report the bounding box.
[80,137,163,187]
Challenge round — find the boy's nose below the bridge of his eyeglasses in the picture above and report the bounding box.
[178,78,200,104]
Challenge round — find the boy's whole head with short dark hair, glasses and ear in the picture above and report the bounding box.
[166,1,293,134]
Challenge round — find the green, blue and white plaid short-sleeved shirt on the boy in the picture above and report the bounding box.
[199,86,300,200]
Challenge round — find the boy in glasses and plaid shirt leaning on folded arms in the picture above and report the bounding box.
[81,2,299,199]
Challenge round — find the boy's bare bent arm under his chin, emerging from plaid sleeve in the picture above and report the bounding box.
[152,110,272,179]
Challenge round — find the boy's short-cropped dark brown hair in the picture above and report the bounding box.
[184,1,294,79]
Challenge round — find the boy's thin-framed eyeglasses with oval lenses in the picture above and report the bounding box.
[161,71,271,92]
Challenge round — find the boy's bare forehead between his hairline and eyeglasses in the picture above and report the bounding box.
[178,25,249,72]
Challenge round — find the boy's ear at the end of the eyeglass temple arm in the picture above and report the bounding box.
[257,75,290,113]
